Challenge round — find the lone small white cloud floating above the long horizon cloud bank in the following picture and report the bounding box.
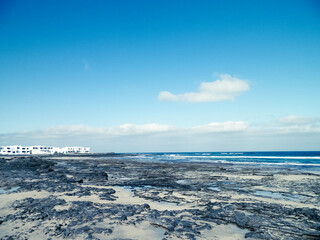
[158,74,250,102]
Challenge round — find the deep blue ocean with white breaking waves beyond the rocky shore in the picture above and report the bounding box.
[117,151,320,173]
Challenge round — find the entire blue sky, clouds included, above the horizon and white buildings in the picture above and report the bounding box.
[0,0,320,152]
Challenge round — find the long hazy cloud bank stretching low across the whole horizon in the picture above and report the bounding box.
[0,115,320,152]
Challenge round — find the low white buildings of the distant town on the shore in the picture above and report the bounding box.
[0,145,90,155]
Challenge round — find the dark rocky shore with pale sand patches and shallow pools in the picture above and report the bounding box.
[0,155,320,240]
